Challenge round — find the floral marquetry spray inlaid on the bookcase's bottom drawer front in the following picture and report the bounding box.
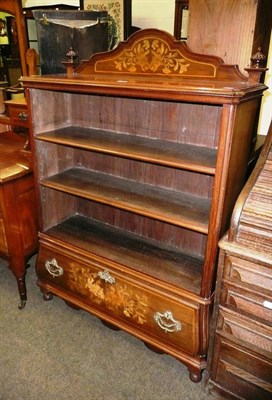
[68,265,148,324]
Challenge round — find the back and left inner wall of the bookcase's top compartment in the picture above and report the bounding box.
[32,90,222,148]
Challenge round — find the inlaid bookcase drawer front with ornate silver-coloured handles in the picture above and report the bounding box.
[37,244,199,355]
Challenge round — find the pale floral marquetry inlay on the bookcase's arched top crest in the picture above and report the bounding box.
[114,39,190,74]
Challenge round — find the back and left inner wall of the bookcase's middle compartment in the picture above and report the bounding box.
[36,140,214,199]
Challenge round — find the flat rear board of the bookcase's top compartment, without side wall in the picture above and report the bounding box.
[72,95,221,148]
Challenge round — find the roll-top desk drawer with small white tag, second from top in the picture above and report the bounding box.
[221,282,272,325]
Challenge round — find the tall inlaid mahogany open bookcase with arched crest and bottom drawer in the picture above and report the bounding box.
[23,29,266,382]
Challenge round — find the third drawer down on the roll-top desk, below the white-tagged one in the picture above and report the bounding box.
[217,309,272,359]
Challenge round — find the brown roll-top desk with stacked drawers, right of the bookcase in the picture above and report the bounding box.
[209,124,272,400]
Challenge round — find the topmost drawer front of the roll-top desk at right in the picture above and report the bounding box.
[225,256,272,291]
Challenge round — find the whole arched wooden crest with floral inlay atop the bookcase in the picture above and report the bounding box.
[75,29,250,81]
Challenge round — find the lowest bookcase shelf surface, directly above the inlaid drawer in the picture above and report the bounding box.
[40,215,203,294]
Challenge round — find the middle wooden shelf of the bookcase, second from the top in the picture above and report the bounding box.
[41,168,210,234]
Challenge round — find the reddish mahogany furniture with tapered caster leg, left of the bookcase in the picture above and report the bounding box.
[0,131,38,308]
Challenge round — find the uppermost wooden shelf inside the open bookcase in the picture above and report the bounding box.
[37,126,216,175]
